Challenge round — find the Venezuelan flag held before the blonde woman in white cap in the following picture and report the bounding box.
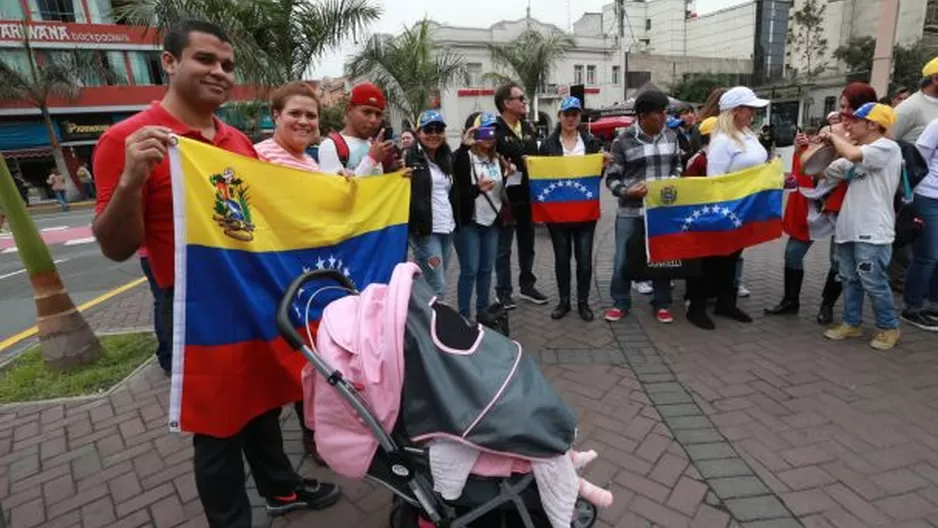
[645,159,784,262]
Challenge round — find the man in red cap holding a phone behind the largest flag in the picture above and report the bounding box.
[319,83,394,176]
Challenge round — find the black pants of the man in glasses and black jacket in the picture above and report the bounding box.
[495,202,537,295]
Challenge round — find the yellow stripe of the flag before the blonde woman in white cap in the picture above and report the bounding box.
[645,158,785,208]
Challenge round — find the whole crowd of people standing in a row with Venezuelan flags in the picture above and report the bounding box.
[82,15,938,527]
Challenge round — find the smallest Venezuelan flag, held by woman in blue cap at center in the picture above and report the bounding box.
[527,154,603,223]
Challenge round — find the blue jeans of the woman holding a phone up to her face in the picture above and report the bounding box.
[455,222,499,318]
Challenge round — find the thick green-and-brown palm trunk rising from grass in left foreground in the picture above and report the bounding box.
[0,155,101,369]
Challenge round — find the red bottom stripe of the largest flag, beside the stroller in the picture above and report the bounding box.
[180,323,318,438]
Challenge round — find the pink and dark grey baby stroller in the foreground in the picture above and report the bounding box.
[277,263,597,528]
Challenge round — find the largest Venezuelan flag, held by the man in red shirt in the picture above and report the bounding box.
[169,138,410,437]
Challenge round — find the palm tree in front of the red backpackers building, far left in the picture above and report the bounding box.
[0,23,110,200]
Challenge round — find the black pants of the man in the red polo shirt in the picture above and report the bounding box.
[160,288,301,528]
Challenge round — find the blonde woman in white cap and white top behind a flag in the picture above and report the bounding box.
[687,86,769,330]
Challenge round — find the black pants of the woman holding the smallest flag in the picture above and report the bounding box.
[547,222,596,302]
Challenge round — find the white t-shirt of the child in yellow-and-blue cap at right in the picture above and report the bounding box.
[824,138,902,244]
